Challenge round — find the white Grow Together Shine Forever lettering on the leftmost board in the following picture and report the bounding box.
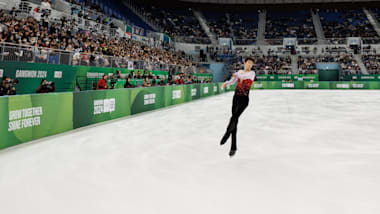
[8,106,43,132]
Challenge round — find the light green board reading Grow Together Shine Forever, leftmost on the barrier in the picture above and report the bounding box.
[0,93,73,149]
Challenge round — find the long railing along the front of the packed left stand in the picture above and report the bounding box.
[0,43,197,73]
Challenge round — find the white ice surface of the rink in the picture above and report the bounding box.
[0,90,380,214]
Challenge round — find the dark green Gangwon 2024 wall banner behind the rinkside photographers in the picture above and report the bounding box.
[0,62,212,94]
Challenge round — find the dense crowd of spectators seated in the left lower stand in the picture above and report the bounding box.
[0,11,192,67]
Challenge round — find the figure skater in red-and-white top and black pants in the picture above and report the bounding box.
[220,57,256,157]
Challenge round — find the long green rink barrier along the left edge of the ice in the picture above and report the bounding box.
[0,83,227,149]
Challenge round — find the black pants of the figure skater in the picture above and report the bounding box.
[225,95,249,150]
